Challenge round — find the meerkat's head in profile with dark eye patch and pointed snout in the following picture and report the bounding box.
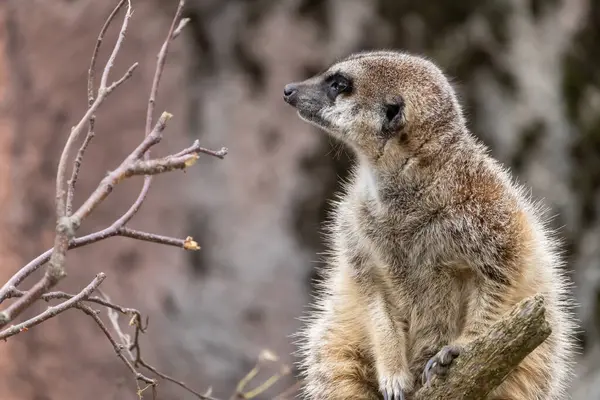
[284,51,464,166]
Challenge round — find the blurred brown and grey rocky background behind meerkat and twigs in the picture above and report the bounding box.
[0,0,600,400]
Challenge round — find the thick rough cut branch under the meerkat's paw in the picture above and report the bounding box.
[415,294,552,400]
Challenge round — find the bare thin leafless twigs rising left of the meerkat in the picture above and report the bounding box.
[0,0,227,399]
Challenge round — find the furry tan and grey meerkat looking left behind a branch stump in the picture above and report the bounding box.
[284,51,576,400]
